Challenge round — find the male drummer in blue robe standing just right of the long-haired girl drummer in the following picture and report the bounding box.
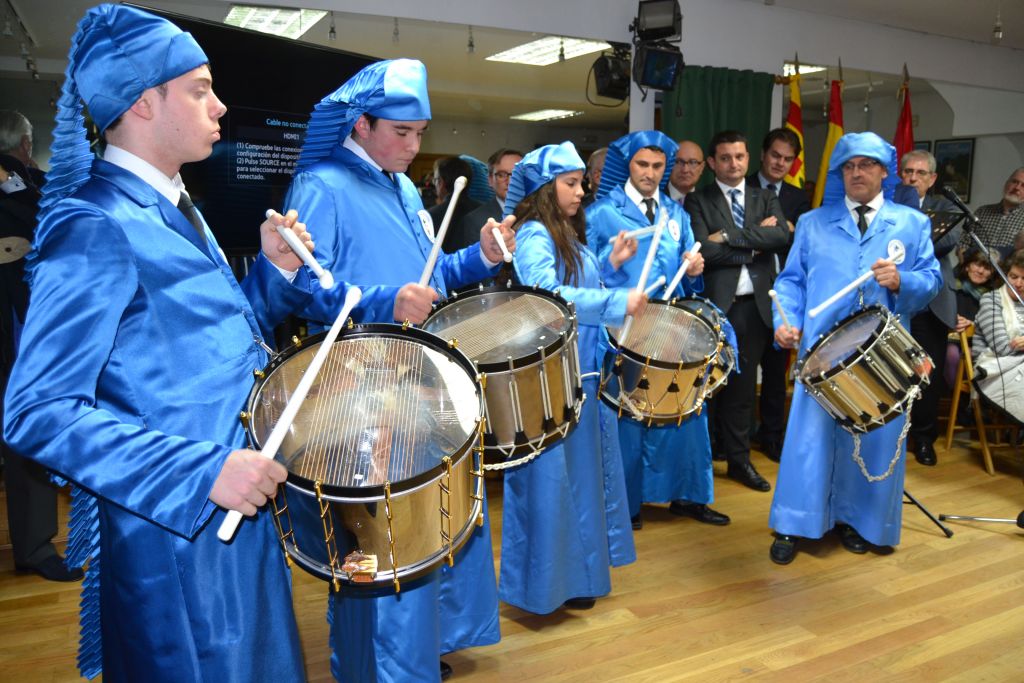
[587,130,735,528]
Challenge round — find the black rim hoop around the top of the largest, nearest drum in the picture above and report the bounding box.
[246,323,483,501]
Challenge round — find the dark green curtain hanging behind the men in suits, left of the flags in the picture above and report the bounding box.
[662,65,775,185]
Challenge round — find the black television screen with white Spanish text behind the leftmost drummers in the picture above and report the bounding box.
[133,7,377,253]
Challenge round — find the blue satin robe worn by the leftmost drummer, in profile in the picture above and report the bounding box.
[5,160,309,682]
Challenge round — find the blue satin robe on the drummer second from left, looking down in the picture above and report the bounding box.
[286,146,501,683]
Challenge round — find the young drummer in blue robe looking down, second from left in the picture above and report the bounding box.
[286,59,515,683]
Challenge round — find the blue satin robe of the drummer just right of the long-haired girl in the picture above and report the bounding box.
[587,187,725,509]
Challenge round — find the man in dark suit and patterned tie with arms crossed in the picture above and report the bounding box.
[686,131,790,490]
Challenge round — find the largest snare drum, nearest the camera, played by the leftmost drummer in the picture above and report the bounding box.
[243,325,483,591]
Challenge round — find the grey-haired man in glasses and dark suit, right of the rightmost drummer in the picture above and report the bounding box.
[897,150,962,466]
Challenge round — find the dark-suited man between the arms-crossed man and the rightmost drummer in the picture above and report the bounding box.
[746,128,811,462]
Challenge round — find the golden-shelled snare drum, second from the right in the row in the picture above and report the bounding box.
[601,301,722,426]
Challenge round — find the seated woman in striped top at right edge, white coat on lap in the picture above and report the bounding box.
[971,250,1024,423]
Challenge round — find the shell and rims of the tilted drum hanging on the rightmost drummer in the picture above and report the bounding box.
[797,307,931,432]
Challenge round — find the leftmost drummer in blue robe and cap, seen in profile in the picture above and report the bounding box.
[4,5,312,682]
